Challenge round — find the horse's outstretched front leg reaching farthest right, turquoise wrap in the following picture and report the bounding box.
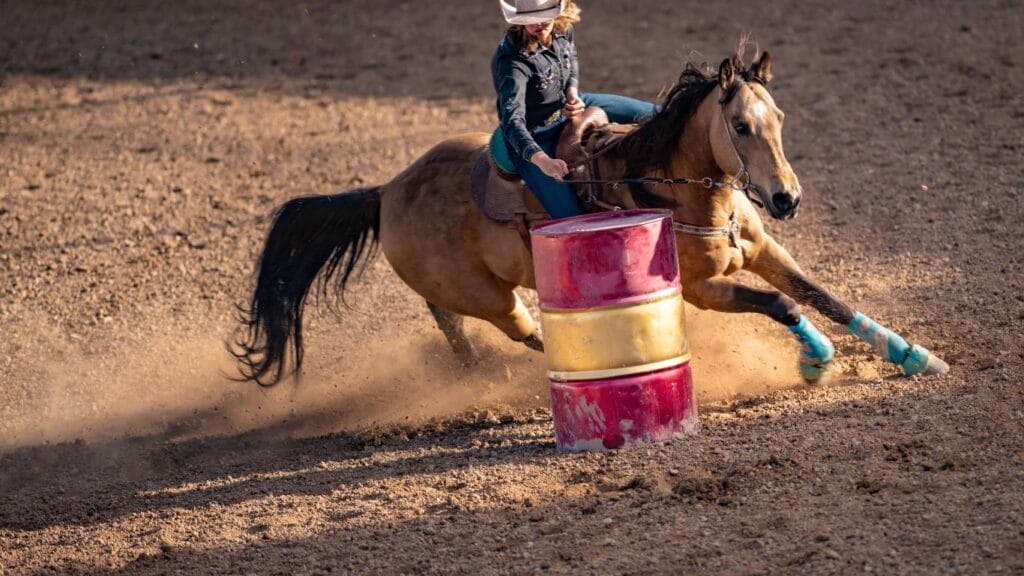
[745,237,949,375]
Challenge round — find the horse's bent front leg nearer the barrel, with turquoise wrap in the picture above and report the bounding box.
[683,276,836,382]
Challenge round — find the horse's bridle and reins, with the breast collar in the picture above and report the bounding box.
[566,79,764,243]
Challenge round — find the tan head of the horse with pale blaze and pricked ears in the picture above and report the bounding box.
[710,52,801,219]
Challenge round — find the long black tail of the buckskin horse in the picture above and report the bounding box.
[229,187,381,386]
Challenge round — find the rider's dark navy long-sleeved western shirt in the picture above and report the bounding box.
[490,26,580,161]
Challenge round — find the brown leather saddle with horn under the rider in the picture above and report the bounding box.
[471,107,608,234]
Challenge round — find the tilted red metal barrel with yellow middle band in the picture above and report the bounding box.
[530,210,697,450]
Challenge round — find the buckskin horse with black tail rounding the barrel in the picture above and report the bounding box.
[229,51,948,386]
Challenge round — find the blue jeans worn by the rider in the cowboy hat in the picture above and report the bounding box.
[506,92,655,218]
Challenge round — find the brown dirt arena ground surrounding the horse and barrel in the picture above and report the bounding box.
[0,0,1024,575]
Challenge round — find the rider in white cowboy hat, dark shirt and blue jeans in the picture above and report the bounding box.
[490,0,654,218]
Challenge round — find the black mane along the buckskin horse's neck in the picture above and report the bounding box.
[609,47,765,208]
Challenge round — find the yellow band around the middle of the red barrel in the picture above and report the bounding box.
[541,292,689,380]
